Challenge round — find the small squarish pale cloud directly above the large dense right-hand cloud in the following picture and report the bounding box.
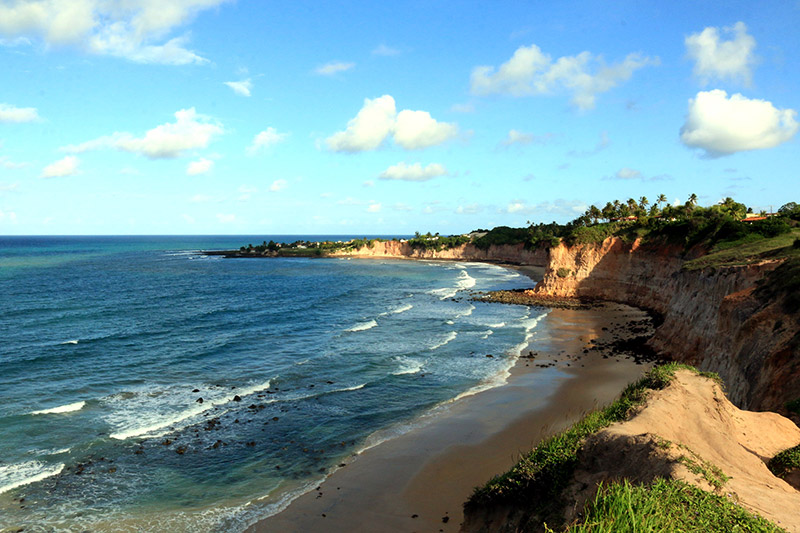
[685,22,756,85]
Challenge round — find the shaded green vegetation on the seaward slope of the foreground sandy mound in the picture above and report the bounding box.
[466,363,719,519]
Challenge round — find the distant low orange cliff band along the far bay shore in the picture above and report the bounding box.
[332,241,549,267]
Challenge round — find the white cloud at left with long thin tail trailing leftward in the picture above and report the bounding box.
[63,107,223,159]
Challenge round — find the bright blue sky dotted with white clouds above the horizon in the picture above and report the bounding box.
[0,0,800,235]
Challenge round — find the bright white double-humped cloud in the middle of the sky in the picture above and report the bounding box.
[325,94,458,153]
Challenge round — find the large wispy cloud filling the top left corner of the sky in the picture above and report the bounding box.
[0,0,228,65]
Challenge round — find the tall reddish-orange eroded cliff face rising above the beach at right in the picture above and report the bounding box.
[535,237,800,410]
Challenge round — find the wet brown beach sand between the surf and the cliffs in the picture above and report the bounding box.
[248,304,650,532]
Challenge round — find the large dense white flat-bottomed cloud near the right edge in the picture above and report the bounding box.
[681,89,798,157]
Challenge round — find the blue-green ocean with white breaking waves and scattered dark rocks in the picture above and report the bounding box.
[0,235,546,532]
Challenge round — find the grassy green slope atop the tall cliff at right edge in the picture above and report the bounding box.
[683,228,800,270]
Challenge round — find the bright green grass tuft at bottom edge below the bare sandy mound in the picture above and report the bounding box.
[548,479,783,533]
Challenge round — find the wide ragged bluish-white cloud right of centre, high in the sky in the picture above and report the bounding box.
[471,44,659,109]
